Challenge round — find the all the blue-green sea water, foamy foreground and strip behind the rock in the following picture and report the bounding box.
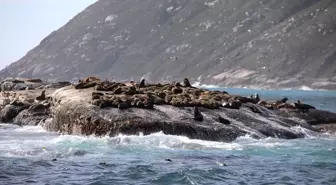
[0,89,336,185]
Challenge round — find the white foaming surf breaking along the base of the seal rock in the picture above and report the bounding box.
[0,124,335,160]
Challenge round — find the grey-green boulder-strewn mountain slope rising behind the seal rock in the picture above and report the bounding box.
[0,0,336,89]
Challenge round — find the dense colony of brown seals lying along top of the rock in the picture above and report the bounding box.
[71,77,320,112]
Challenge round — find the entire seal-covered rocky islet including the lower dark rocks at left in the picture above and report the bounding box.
[0,77,336,142]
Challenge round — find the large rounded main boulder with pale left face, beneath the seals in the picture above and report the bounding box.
[45,77,335,141]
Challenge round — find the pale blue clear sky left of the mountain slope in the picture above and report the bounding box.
[0,0,97,69]
